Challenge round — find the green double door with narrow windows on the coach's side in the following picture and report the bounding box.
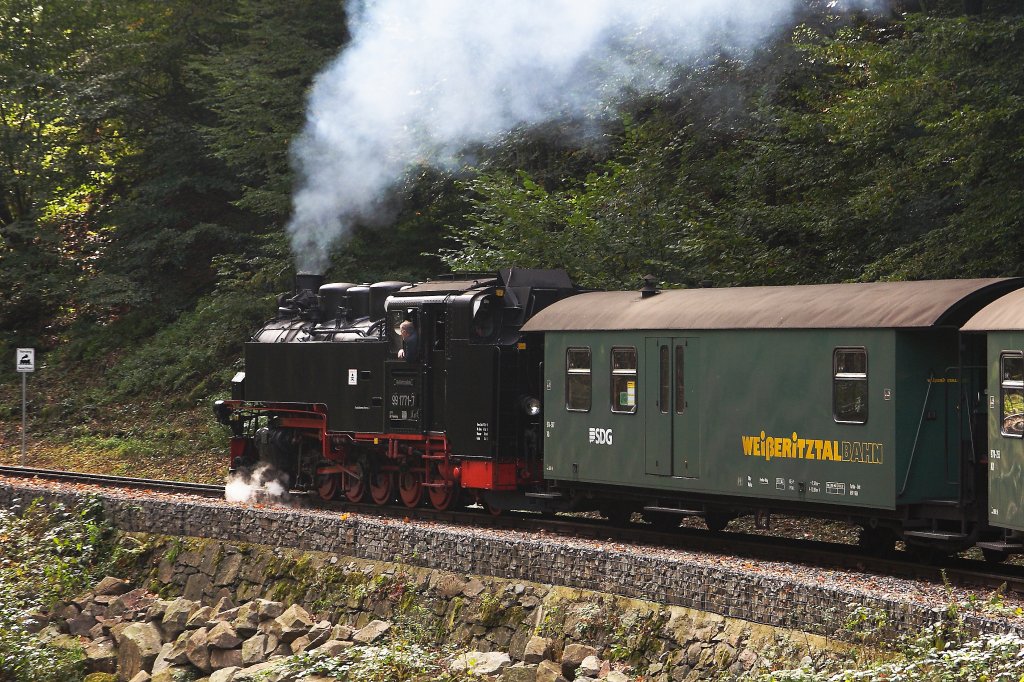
[644,337,700,478]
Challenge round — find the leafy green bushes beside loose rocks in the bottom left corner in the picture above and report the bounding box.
[0,493,116,682]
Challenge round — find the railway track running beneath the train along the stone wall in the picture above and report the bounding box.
[0,466,1024,595]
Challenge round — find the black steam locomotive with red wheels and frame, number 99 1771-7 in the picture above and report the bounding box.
[216,268,577,509]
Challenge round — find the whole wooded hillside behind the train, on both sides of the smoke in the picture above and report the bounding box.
[0,0,1024,480]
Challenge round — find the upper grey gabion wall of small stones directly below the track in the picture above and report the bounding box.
[0,483,1008,636]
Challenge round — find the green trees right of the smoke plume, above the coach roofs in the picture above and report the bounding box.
[443,11,1024,288]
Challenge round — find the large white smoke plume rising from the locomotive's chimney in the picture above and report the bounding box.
[289,0,872,272]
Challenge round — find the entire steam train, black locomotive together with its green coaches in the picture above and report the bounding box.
[214,268,1024,560]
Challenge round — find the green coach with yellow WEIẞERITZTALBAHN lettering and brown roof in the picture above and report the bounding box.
[523,280,1024,550]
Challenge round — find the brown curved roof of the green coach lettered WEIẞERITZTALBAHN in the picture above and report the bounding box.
[522,278,1024,332]
